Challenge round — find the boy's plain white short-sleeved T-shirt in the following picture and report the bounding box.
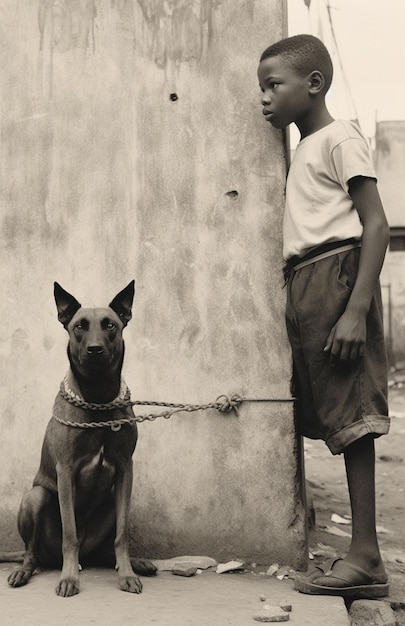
[283,120,376,260]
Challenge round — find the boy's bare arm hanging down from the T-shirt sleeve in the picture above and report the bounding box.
[324,176,389,366]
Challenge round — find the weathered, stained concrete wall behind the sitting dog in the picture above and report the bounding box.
[0,0,306,566]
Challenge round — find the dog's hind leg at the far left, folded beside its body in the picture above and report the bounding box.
[8,486,51,587]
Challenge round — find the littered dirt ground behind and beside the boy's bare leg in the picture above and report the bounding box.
[305,372,405,626]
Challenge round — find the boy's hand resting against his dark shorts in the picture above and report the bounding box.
[324,311,366,367]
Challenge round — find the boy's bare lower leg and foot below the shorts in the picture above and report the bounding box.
[313,435,387,587]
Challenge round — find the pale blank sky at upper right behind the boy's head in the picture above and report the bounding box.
[287,0,405,137]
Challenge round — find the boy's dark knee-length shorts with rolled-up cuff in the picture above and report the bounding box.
[286,248,389,454]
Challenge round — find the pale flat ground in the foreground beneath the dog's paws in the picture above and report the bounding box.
[0,563,349,626]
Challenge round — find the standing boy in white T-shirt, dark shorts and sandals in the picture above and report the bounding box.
[258,35,389,598]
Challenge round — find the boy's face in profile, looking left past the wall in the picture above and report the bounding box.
[257,56,311,128]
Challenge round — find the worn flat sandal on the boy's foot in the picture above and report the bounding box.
[294,559,389,600]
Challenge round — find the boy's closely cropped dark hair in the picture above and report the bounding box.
[260,35,333,93]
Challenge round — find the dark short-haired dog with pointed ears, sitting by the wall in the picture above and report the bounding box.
[8,281,156,597]
